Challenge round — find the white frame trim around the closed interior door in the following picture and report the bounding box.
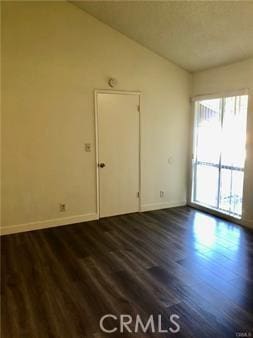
[94,89,142,218]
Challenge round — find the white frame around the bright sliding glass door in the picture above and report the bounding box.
[187,89,249,225]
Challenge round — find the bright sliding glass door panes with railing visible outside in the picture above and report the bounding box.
[191,95,248,217]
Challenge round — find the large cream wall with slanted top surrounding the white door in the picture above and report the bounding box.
[2,1,191,232]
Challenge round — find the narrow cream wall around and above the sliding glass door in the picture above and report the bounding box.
[193,58,253,227]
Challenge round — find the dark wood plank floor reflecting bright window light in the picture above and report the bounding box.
[1,207,253,338]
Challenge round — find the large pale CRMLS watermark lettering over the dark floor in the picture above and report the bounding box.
[99,313,180,333]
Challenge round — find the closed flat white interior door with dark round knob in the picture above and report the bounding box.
[97,93,140,217]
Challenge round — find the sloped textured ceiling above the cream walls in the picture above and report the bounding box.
[71,0,253,72]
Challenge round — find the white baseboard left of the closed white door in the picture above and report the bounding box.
[0,213,98,235]
